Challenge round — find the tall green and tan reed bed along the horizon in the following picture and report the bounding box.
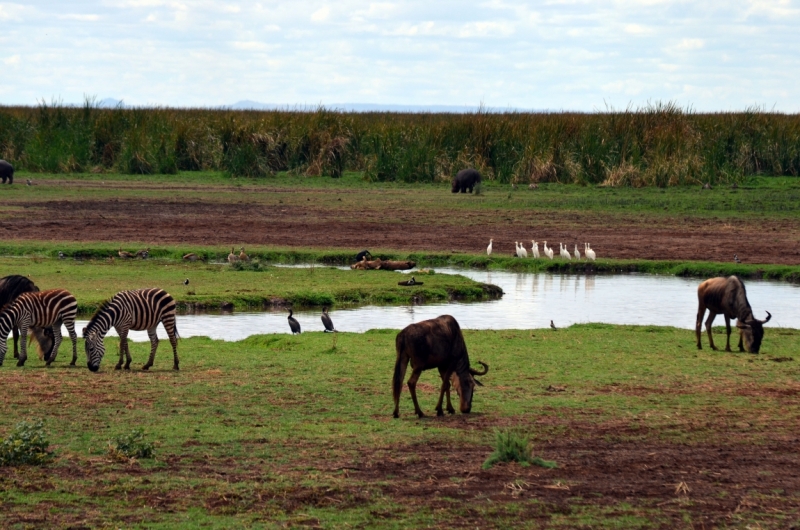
[0,100,800,187]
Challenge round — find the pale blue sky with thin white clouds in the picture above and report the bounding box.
[0,0,800,112]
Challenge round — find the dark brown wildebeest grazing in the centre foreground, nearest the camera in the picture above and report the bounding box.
[392,315,489,418]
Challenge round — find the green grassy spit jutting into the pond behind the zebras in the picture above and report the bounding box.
[0,254,502,312]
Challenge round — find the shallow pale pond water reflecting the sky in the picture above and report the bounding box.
[70,268,800,341]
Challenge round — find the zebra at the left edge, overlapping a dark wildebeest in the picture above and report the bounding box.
[0,289,78,366]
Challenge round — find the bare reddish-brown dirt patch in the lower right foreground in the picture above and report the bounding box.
[346,439,800,528]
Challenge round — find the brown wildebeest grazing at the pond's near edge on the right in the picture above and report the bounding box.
[695,276,772,353]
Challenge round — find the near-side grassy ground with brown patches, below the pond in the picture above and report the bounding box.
[0,324,800,528]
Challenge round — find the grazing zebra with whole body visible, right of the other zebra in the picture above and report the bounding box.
[83,289,178,372]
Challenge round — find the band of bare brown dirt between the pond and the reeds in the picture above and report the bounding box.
[0,184,800,265]
